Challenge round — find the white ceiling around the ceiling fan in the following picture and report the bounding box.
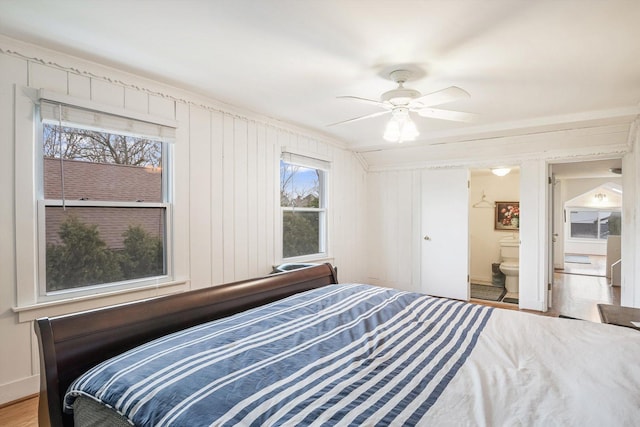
[0,0,640,151]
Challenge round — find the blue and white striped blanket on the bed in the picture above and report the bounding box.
[65,285,492,426]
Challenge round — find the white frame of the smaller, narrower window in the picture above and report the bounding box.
[278,149,331,263]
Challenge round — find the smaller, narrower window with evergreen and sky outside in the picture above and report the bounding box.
[280,153,329,259]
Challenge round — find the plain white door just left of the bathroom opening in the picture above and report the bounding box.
[421,169,469,301]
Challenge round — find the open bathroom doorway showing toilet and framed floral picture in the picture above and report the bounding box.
[469,166,520,306]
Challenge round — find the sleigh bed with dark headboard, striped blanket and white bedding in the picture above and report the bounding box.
[35,264,640,426]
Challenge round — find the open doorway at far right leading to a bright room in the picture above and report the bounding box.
[549,159,624,321]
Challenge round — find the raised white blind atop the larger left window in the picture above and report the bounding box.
[40,100,176,142]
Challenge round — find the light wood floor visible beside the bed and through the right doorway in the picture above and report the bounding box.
[0,260,620,427]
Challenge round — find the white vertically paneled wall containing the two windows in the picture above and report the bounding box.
[0,38,368,404]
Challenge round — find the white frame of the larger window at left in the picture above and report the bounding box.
[34,98,175,303]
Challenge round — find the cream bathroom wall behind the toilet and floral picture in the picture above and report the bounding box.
[469,169,520,283]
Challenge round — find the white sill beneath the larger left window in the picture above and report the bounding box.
[12,280,189,323]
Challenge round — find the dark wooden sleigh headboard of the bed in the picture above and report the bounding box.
[34,263,337,427]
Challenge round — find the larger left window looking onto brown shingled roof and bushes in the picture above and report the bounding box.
[38,101,174,296]
